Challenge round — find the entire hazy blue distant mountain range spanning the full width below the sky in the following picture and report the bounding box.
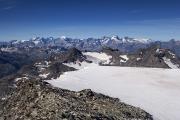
[0,36,180,56]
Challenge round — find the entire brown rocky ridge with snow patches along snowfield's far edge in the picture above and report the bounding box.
[102,45,180,68]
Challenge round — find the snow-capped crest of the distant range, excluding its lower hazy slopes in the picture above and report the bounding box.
[12,35,152,47]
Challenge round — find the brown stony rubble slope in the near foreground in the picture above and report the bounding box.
[0,80,153,120]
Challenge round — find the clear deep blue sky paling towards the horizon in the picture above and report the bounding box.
[0,0,180,41]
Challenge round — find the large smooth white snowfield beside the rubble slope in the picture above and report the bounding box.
[48,63,180,120]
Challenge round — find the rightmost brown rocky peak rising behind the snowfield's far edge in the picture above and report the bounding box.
[124,45,180,68]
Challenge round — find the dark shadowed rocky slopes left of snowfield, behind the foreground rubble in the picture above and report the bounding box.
[0,48,82,97]
